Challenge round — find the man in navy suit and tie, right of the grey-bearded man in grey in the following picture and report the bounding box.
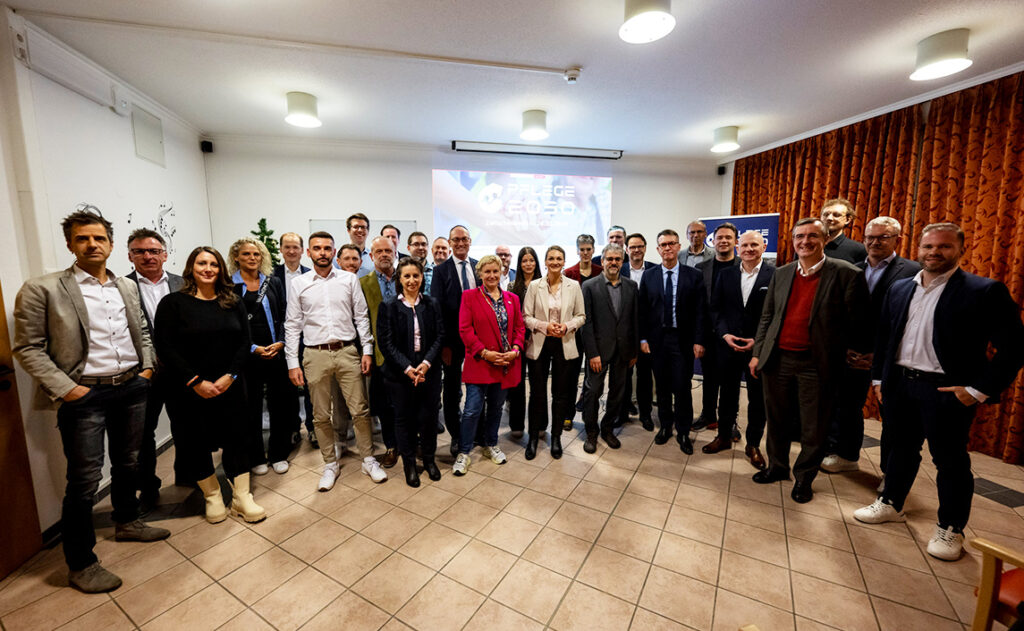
[640,229,708,455]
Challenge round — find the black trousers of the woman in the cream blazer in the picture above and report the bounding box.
[529,337,580,436]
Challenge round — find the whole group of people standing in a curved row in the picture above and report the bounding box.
[14,200,1024,592]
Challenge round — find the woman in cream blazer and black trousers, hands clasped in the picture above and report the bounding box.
[522,246,587,460]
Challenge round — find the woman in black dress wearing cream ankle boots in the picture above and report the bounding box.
[154,246,266,523]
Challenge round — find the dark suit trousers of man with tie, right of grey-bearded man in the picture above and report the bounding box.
[650,329,693,437]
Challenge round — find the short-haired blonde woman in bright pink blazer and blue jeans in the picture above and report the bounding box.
[452,254,525,475]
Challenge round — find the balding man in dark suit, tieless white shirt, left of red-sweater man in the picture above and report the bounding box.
[700,230,775,469]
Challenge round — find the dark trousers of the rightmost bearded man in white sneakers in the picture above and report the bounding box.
[882,367,975,532]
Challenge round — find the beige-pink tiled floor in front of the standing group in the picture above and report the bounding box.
[0,385,1024,631]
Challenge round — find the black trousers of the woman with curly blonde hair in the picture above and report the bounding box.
[246,352,299,466]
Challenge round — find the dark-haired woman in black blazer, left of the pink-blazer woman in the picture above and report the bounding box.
[377,256,444,487]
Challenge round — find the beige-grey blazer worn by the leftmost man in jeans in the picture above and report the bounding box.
[13,266,157,408]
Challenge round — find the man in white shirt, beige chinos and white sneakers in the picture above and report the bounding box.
[285,232,387,491]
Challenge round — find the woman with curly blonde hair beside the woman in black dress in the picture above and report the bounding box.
[227,237,299,475]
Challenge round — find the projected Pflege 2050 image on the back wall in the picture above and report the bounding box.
[433,169,611,258]
